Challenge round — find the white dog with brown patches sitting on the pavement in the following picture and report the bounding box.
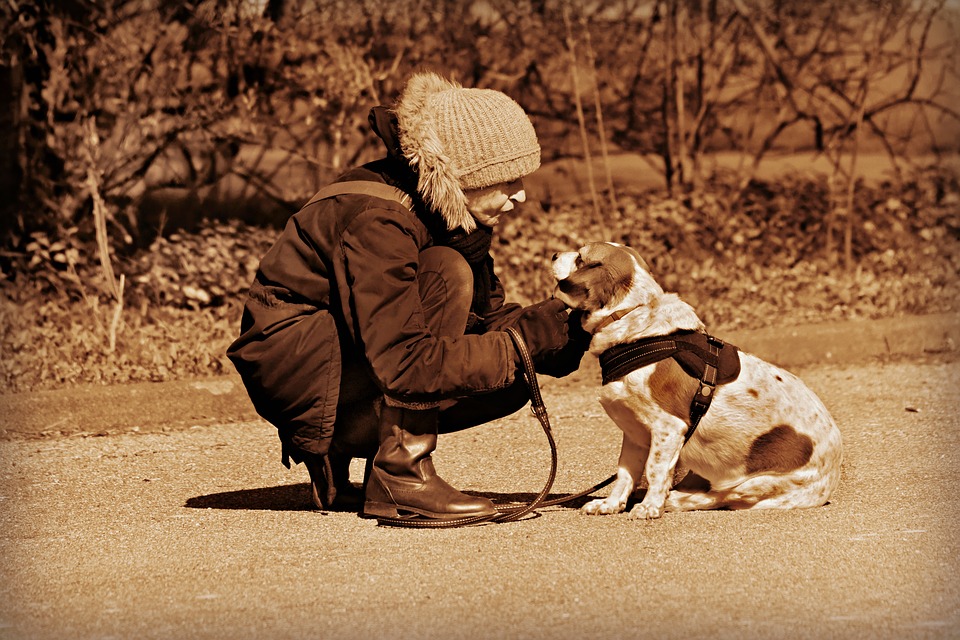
[552,243,843,519]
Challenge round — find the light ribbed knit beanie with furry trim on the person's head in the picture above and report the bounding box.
[394,72,540,232]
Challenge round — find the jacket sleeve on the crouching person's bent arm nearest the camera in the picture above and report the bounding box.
[340,209,515,408]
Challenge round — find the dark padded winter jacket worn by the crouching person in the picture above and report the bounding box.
[228,122,520,448]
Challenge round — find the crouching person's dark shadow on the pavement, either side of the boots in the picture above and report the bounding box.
[184,483,592,511]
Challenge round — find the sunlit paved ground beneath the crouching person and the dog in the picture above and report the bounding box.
[0,317,960,639]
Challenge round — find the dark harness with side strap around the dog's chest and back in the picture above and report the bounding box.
[600,331,740,442]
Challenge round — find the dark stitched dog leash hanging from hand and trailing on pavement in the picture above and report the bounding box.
[377,327,617,529]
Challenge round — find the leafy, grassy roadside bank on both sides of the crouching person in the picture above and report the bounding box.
[0,171,960,393]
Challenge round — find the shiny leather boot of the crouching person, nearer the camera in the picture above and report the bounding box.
[363,406,497,520]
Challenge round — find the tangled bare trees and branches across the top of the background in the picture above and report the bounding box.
[0,0,960,282]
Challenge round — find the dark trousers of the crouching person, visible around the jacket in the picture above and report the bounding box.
[333,247,530,457]
